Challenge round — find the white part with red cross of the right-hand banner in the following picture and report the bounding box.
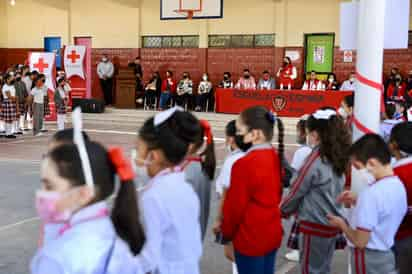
[63,46,86,79]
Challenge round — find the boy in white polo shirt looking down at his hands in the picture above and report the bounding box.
[328,134,408,274]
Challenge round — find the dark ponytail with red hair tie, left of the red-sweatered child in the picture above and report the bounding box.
[199,120,216,180]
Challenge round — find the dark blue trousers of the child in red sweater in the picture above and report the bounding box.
[235,250,277,274]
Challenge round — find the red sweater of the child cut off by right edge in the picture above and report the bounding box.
[394,157,412,240]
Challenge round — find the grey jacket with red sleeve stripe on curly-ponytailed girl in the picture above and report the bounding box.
[281,148,345,238]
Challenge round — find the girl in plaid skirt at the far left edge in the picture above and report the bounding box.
[2,73,17,139]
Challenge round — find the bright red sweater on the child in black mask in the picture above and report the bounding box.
[222,148,282,256]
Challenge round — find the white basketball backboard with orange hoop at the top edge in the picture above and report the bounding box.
[160,0,223,20]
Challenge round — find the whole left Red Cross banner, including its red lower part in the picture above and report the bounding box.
[28,52,57,121]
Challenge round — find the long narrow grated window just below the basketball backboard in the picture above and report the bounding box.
[143,35,199,48]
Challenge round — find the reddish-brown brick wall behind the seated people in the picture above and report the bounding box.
[0,47,412,95]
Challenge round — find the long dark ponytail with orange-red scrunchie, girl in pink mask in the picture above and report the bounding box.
[109,148,145,255]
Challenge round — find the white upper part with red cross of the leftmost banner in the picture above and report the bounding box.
[29,52,56,91]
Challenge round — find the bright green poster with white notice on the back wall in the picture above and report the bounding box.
[305,33,335,74]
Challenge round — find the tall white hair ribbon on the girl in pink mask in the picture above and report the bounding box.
[72,107,94,189]
